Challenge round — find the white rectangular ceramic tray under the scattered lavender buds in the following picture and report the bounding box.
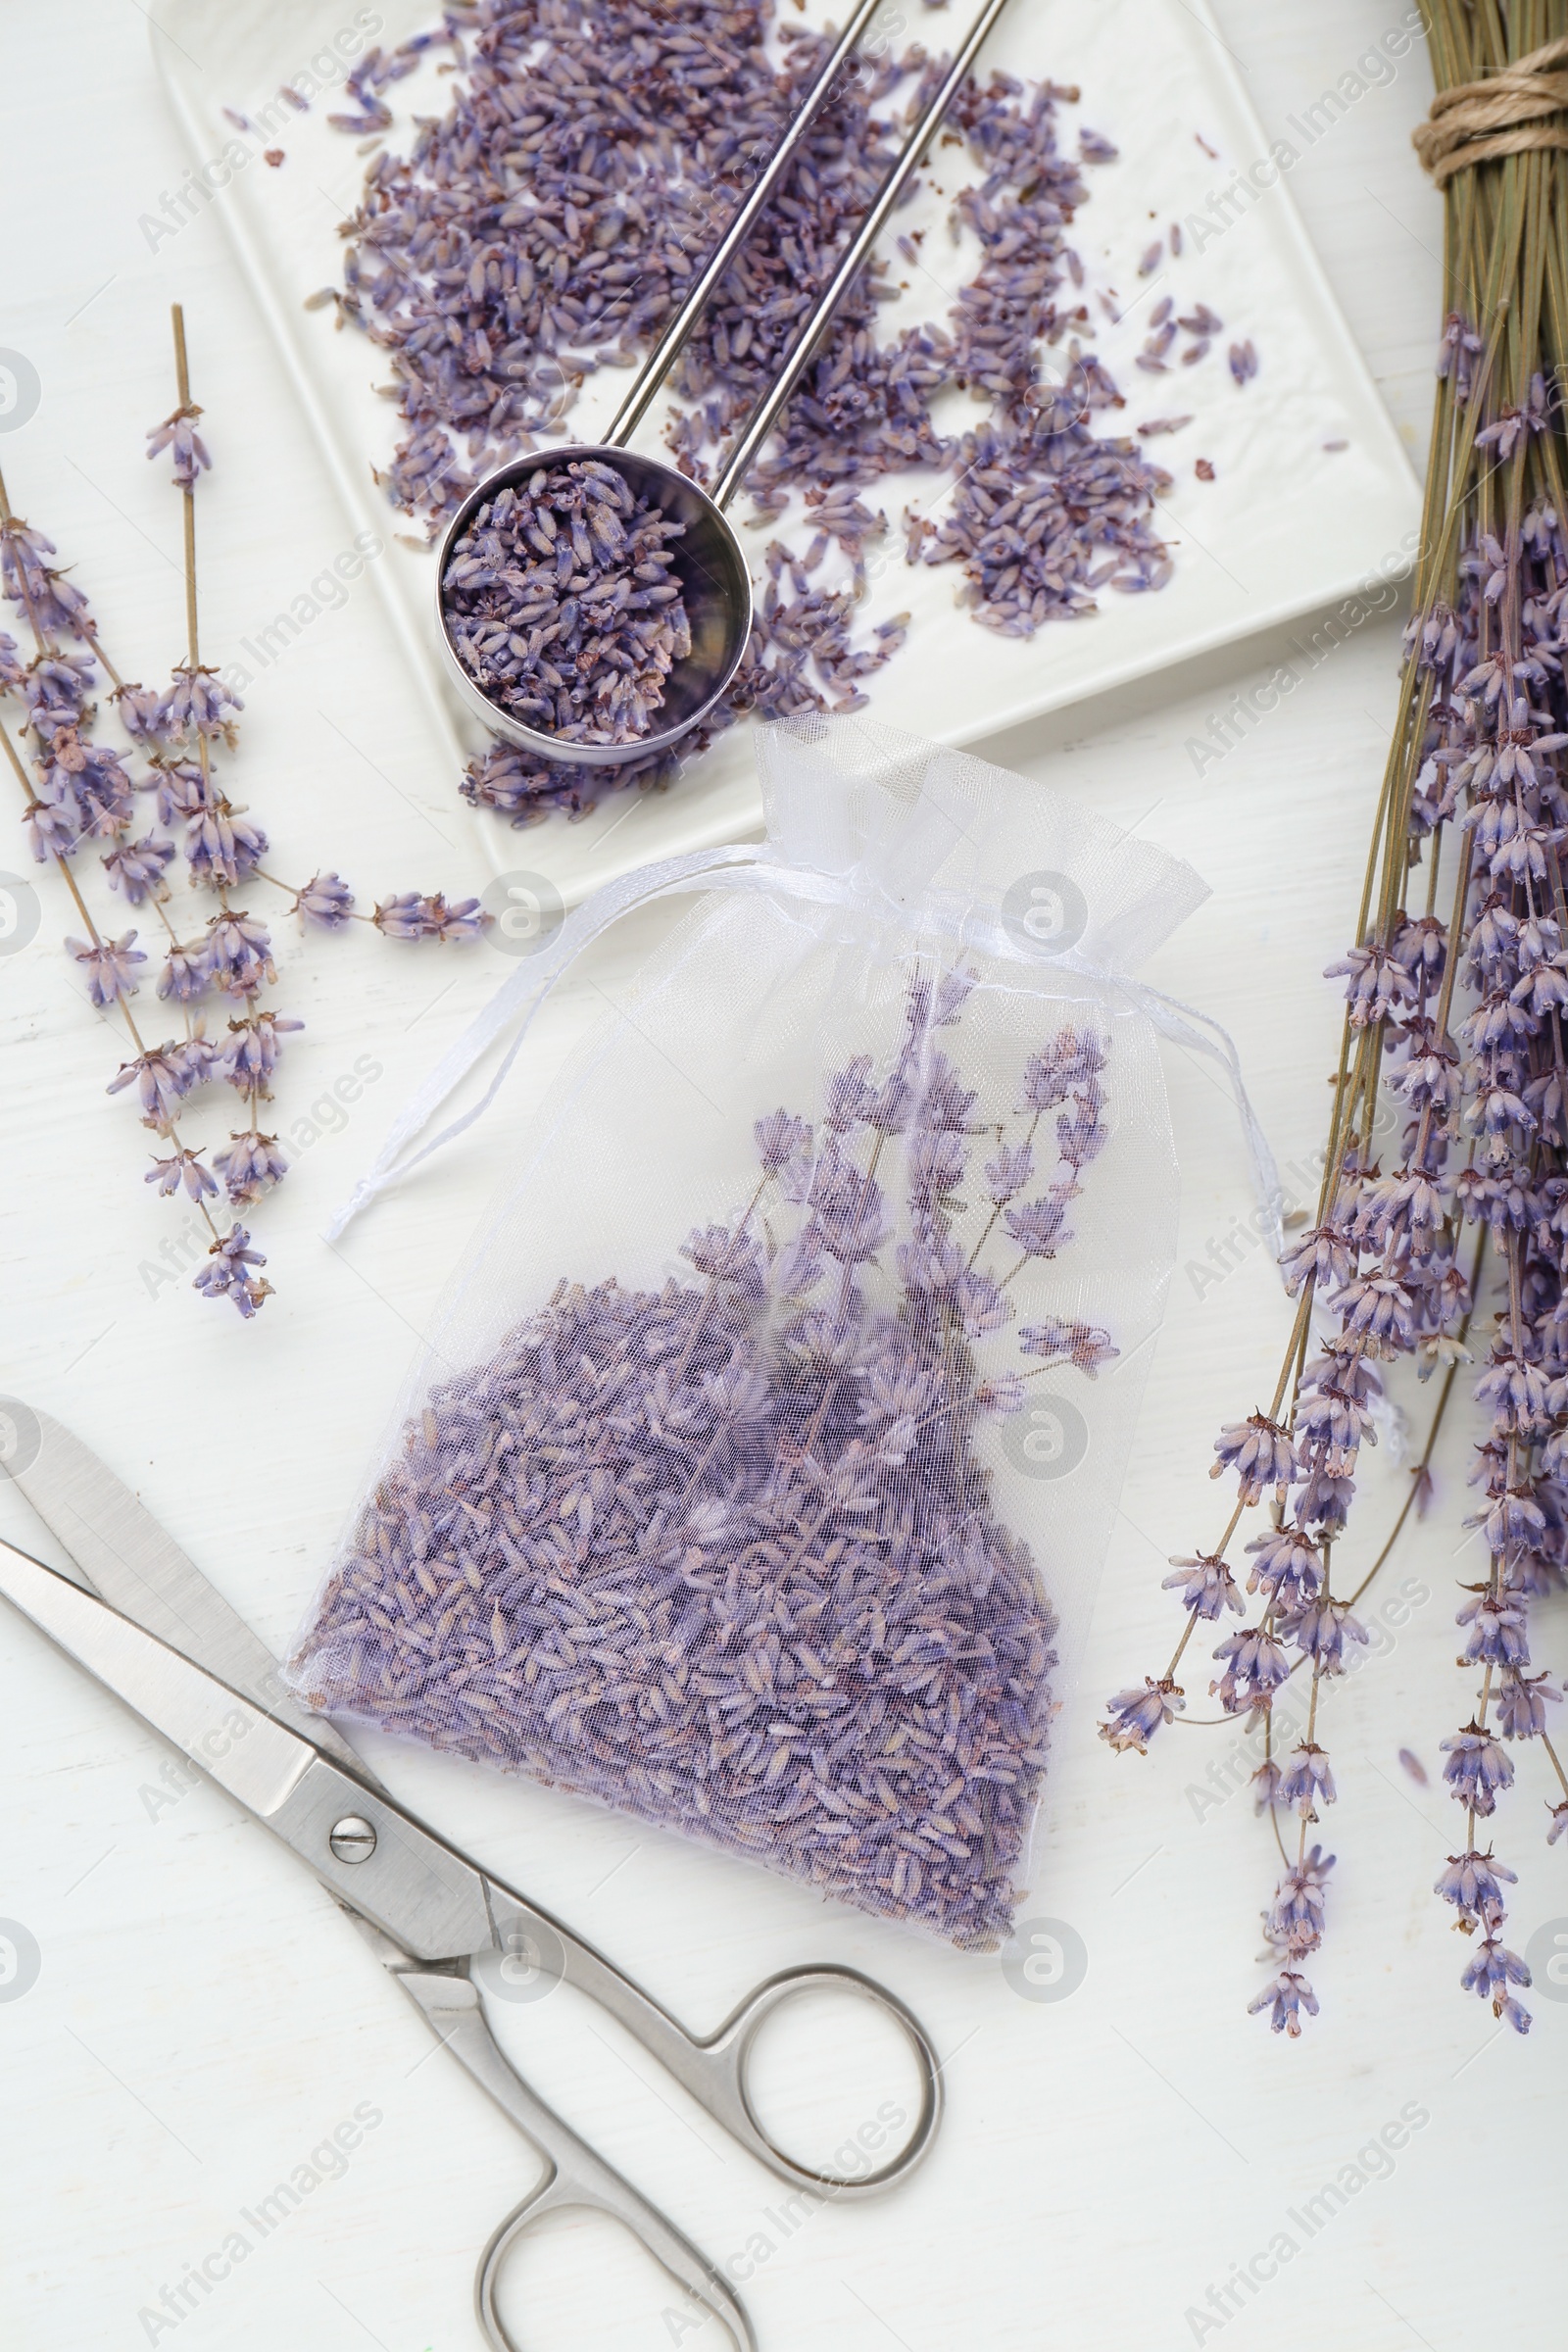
[153,0,1417,904]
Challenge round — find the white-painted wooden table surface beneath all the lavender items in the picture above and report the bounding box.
[0,14,1568,2352]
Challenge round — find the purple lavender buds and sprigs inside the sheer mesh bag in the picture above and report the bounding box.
[289,974,1116,1950]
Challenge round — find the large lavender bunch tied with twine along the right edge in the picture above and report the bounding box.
[1102,0,1568,2034]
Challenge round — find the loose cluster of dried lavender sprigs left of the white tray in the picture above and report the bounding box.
[0,308,489,1319]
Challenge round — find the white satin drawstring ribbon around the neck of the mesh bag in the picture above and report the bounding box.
[326,842,1284,1256]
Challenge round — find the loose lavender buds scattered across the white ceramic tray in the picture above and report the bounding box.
[329,0,1250,823]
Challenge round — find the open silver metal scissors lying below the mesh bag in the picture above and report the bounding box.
[0,1401,943,2352]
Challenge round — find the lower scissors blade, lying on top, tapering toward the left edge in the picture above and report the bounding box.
[0,1543,315,1821]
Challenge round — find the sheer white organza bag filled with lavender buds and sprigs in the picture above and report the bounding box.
[289,717,1259,1950]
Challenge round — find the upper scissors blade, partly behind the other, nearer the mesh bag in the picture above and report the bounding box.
[10,1406,373,1778]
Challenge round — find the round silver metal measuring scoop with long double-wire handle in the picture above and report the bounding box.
[435,0,1006,766]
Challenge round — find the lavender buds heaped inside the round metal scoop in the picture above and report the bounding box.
[442,459,691,743]
